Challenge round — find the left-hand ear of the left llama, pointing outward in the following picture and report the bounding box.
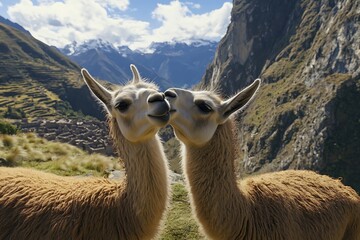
[81,68,111,109]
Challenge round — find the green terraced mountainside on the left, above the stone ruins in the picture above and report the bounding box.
[0,23,103,119]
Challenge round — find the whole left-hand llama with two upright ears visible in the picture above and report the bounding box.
[0,65,170,239]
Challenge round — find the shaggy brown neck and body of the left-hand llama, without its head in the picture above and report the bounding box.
[0,96,169,240]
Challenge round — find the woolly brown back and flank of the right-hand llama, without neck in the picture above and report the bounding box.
[239,170,360,240]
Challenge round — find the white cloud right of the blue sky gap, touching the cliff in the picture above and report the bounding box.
[152,1,232,42]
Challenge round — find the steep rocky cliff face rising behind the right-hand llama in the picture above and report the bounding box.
[201,0,360,191]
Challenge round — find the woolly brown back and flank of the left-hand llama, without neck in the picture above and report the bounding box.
[0,168,148,239]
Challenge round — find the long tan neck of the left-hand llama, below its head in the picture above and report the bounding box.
[110,120,169,225]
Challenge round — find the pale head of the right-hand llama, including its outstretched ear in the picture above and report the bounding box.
[165,79,261,146]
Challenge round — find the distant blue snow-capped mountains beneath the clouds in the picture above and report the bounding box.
[60,39,217,89]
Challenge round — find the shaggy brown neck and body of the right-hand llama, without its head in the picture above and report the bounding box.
[183,119,360,240]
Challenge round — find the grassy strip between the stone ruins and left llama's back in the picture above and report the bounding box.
[0,133,120,176]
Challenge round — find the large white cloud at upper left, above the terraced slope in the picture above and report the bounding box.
[8,0,149,47]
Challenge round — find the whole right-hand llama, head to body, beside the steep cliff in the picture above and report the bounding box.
[165,80,360,240]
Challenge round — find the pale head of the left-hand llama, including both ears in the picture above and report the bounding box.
[81,65,170,142]
